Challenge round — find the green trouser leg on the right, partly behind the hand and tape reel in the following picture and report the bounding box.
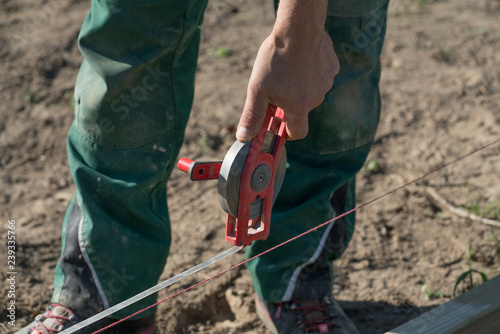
[247,0,387,302]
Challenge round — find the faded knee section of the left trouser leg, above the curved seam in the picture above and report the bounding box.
[75,0,206,149]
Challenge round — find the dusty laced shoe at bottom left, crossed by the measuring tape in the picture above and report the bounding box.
[15,304,156,334]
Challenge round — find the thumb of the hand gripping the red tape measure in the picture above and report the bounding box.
[236,90,268,143]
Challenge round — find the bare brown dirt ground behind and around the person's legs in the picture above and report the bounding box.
[0,0,500,334]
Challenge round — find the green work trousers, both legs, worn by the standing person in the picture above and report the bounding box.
[53,0,387,318]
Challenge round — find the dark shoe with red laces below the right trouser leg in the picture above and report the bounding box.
[255,294,359,334]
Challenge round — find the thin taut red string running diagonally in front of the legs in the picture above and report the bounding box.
[92,139,500,334]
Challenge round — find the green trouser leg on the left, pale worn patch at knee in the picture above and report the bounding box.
[53,0,206,317]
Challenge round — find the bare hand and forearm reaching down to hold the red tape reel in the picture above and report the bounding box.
[236,0,339,142]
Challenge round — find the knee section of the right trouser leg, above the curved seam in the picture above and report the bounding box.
[293,1,387,155]
